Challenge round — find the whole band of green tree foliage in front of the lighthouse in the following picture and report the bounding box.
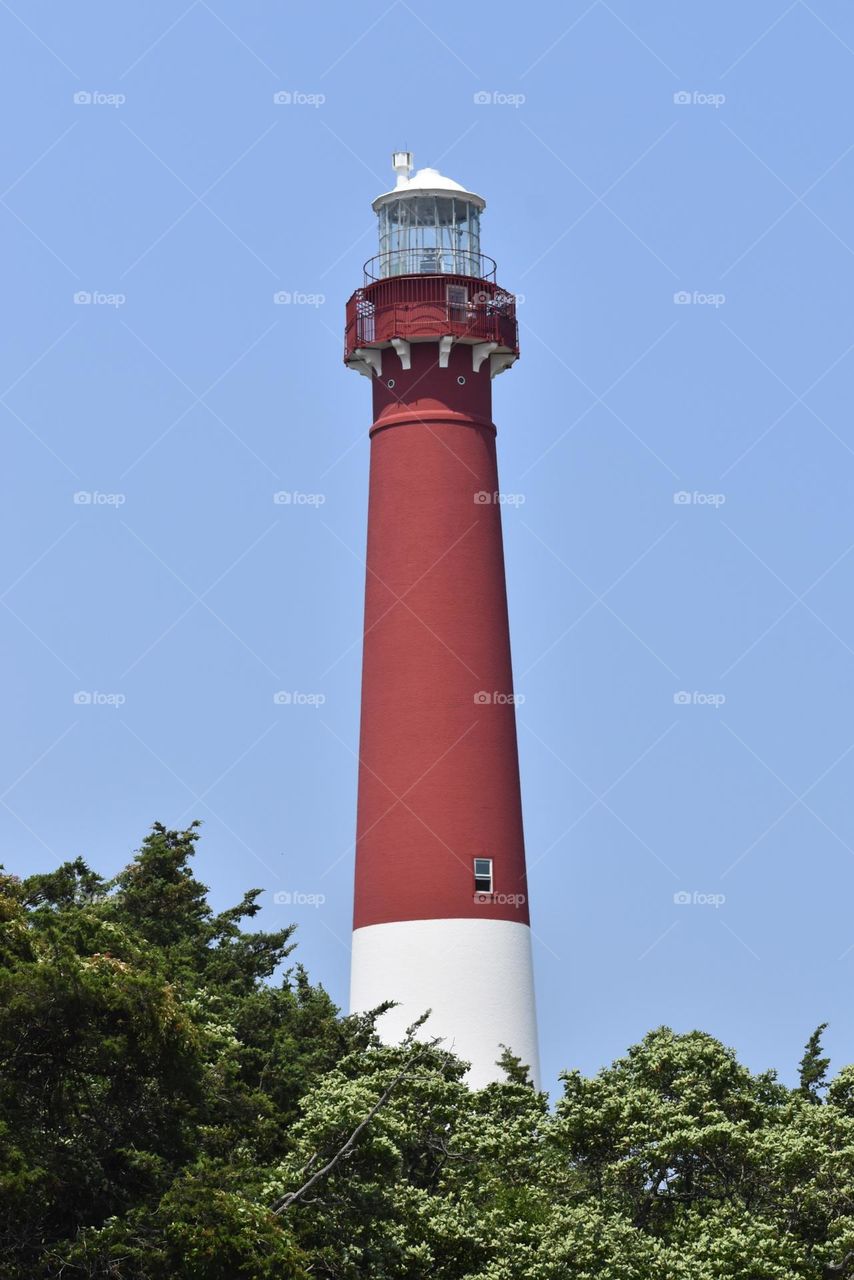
[0,826,854,1280]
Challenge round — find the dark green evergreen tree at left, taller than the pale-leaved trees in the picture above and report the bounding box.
[0,824,361,1280]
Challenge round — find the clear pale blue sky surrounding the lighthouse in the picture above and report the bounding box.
[0,0,854,1088]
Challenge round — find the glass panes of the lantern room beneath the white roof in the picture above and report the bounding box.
[379,195,480,279]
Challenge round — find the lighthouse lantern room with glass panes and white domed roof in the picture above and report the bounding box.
[373,151,485,280]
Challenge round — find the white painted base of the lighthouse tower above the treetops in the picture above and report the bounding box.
[350,918,540,1089]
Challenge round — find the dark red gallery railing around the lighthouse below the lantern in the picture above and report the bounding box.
[344,275,519,360]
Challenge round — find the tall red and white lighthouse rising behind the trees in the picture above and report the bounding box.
[344,151,539,1088]
